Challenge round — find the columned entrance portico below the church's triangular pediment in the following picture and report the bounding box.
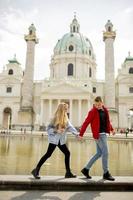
[40,98,90,127]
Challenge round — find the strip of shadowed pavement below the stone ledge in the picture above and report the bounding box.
[0,191,133,200]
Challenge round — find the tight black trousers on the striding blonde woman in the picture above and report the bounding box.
[37,142,70,171]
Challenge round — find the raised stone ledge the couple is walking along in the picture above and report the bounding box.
[0,175,133,191]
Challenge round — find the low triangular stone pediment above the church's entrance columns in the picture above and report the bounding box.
[43,83,89,95]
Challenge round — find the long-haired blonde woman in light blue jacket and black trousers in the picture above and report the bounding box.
[31,103,79,179]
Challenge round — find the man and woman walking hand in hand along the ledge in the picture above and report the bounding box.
[31,96,115,181]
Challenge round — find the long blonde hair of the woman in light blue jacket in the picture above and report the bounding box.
[52,102,68,129]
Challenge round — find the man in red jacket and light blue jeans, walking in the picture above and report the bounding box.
[79,96,115,181]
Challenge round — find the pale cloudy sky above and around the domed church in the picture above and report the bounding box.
[0,0,133,80]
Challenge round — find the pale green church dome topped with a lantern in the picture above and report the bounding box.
[54,18,95,58]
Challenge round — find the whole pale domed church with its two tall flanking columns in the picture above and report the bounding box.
[0,16,133,130]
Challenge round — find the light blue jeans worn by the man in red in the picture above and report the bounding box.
[85,133,108,173]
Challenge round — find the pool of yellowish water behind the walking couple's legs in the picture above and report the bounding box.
[0,135,133,176]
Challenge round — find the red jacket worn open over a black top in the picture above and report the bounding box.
[80,106,113,139]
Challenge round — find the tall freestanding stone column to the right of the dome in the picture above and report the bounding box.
[103,20,116,110]
